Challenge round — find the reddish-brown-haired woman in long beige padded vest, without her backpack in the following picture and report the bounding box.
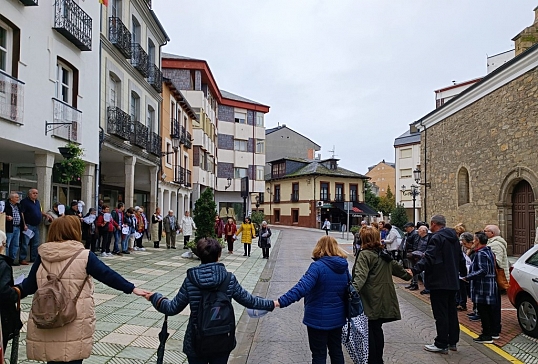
[19,216,148,364]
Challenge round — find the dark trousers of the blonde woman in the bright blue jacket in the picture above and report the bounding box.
[307,326,344,364]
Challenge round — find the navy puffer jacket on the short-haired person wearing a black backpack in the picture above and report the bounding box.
[151,263,275,357]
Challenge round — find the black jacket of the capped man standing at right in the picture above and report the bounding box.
[412,228,467,291]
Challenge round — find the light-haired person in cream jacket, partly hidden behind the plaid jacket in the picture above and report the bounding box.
[484,225,510,339]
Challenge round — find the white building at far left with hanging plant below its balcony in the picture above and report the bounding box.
[0,0,101,209]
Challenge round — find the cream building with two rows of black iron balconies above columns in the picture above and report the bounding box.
[99,0,169,211]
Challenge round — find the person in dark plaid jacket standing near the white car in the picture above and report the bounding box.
[458,232,499,344]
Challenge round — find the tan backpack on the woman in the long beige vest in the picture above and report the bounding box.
[31,249,89,329]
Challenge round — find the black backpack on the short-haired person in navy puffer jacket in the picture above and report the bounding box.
[191,273,235,357]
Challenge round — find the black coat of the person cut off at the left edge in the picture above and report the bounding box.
[0,255,22,341]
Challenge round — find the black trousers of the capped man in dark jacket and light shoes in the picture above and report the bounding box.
[430,289,460,349]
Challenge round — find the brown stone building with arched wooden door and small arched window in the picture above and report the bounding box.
[414,8,538,255]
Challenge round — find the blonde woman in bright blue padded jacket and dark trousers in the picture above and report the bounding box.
[275,235,351,364]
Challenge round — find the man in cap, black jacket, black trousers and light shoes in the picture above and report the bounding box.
[409,215,467,354]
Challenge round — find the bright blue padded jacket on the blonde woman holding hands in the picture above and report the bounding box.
[278,257,351,330]
